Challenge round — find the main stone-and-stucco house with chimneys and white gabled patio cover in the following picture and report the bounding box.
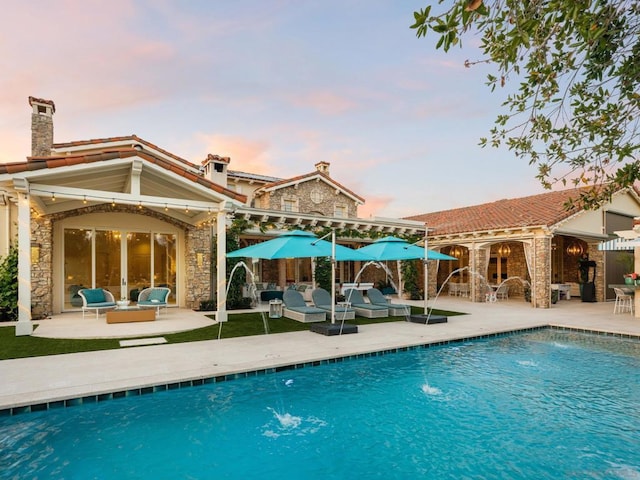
[0,97,424,335]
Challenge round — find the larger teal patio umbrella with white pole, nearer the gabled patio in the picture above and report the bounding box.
[227,230,373,323]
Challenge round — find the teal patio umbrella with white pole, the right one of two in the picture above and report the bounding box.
[358,236,458,315]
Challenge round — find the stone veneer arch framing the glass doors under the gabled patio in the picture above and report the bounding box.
[31,204,202,319]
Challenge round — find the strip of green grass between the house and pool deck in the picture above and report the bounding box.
[0,307,464,360]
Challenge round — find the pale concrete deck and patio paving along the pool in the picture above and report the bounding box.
[0,297,640,412]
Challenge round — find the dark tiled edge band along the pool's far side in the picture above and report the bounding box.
[0,324,640,417]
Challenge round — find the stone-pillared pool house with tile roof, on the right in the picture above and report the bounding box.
[407,188,640,308]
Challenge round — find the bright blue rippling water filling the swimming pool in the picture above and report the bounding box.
[0,330,640,479]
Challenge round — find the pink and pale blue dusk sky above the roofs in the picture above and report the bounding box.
[0,0,544,217]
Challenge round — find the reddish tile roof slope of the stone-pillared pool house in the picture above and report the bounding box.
[405,187,590,235]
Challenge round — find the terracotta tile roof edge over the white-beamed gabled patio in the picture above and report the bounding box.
[0,148,247,203]
